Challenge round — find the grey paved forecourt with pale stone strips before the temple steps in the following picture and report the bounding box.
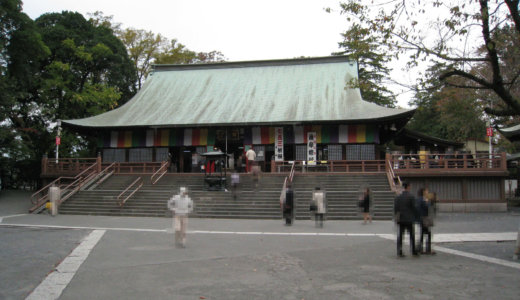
[0,192,520,299]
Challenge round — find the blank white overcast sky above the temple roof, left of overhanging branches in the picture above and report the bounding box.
[23,0,410,107]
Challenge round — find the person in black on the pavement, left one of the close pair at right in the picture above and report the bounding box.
[394,182,419,257]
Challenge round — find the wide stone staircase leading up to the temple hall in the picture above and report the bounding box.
[59,174,394,220]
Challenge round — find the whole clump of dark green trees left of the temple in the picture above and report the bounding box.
[0,7,135,187]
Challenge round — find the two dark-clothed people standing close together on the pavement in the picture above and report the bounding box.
[394,182,435,257]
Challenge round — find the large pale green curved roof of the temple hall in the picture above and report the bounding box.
[63,56,414,128]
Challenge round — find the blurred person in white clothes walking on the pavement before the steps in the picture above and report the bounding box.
[168,187,193,248]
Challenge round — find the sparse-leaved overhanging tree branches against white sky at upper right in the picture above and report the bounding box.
[341,0,520,116]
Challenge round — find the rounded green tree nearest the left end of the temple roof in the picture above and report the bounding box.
[31,12,135,162]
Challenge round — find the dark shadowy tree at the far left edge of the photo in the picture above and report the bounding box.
[0,0,50,188]
